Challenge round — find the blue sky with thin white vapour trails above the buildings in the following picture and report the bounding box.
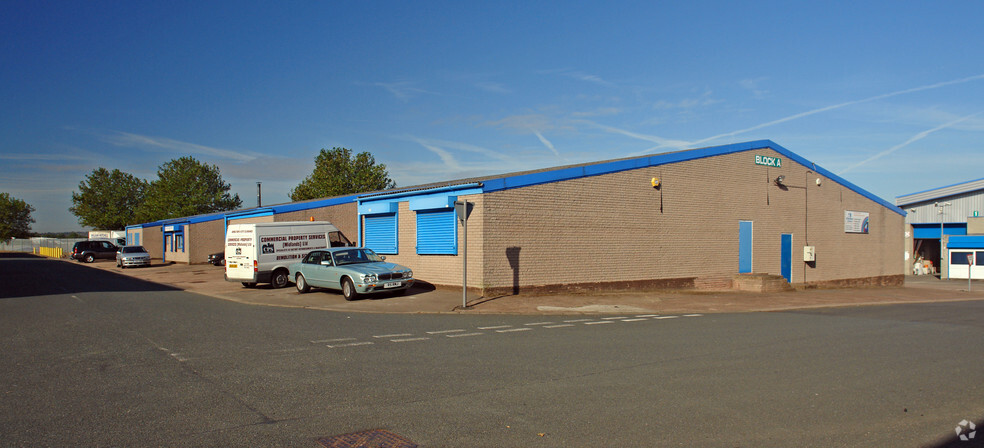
[0,0,984,232]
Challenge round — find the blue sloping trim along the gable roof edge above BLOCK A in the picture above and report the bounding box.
[482,140,906,216]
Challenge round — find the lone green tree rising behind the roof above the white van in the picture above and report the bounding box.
[290,148,396,201]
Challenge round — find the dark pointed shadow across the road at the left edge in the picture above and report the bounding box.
[0,253,178,299]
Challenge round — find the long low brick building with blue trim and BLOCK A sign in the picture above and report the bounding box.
[127,140,906,296]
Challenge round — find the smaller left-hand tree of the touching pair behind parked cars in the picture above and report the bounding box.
[68,167,147,230]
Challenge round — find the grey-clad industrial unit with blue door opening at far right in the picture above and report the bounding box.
[895,179,984,279]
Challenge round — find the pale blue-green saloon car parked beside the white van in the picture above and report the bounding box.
[289,247,413,300]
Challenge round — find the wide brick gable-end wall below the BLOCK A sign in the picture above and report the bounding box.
[483,149,904,292]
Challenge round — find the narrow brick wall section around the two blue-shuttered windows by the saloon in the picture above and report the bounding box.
[374,195,484,289]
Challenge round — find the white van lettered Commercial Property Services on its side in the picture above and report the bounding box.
[225,221,347,288]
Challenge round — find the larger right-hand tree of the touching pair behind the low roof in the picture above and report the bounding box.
[137,156,243,222]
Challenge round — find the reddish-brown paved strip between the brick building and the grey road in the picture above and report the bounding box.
[71,260,984,314]
